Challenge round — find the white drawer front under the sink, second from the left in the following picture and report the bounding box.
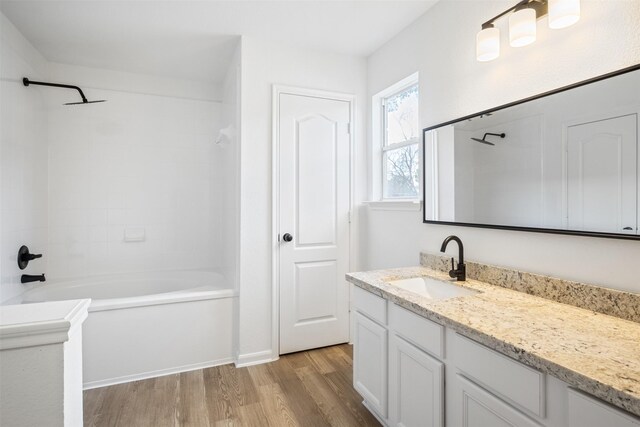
[389,304,444,359]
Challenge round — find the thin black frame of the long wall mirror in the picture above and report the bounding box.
[422,64,640,240]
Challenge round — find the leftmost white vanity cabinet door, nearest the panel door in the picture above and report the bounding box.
[353,312,387,418]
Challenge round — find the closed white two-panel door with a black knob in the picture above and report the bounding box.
[277,93,350,354]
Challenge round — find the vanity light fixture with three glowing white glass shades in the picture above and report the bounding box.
[476,0,580,62]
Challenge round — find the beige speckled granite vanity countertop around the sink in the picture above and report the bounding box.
[347,267,640,416]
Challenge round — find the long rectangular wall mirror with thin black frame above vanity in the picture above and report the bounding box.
[422,65,640,239]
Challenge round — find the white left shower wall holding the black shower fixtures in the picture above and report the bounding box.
[0,13,47,302]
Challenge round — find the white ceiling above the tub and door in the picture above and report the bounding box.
[0,0,436,82]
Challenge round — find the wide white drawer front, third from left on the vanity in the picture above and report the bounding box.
[453,334,545,418]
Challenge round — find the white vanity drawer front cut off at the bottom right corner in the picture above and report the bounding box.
[568,389,640,427]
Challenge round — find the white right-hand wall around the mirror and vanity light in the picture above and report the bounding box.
[364,0,640,292]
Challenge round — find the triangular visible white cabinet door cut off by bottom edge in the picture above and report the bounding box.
[451,375,540,427]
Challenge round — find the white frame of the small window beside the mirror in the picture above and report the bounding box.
[379,83,423,202]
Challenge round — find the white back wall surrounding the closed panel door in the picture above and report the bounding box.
[239,37,366,362]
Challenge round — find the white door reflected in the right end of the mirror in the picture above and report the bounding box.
[566,114,638,234]
